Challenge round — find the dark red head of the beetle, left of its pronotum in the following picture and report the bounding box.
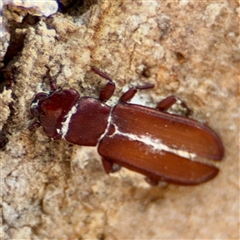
[30,89,80,139]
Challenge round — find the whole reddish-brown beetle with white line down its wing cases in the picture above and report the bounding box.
[30,67,224,185]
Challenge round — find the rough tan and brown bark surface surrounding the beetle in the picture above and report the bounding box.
[0,0,240,240]
